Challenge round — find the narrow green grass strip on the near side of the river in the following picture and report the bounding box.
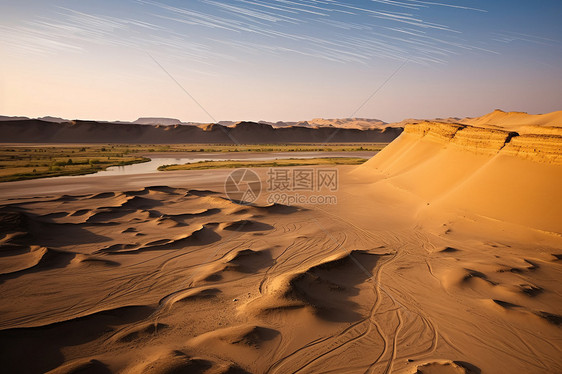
[158,157,367,171]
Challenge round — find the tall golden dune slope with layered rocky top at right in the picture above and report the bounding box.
[356,111,562,233]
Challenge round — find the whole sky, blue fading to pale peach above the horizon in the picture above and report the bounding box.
[0,0,562,122]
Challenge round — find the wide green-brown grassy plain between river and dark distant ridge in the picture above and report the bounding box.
[0,143,387,182]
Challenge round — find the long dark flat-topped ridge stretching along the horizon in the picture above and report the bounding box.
[0,117,403,144]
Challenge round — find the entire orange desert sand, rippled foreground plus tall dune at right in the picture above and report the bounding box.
[0,112,562,373]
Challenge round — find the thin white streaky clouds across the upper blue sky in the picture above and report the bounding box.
[0,0,494,64]
